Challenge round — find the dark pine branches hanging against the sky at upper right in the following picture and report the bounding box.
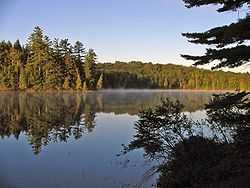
[182,0,250,69]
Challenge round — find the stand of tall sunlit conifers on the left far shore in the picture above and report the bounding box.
[0,27,96,90]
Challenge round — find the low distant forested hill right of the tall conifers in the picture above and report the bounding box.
[97,61,250,90]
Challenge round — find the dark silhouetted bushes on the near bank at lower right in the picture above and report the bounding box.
[123,92,250,188]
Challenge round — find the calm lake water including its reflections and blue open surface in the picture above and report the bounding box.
[0,90,216,188]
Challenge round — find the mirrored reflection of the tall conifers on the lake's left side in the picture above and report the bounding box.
[0,93,95,154]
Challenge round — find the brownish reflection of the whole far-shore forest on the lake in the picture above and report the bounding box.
[0,91,215,154]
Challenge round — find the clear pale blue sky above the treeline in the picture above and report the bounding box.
[0,0,242,70]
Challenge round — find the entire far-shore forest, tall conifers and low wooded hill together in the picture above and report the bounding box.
[0,27,250,91]
